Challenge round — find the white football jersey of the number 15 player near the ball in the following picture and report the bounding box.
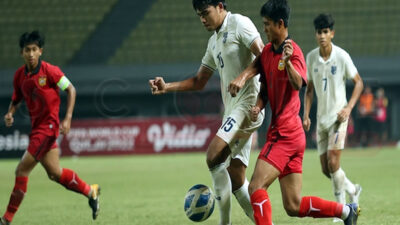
[202,12,260,118]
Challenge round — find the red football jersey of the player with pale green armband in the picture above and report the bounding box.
[12,60,64,136]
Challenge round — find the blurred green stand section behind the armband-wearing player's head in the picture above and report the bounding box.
[0,0,118,68]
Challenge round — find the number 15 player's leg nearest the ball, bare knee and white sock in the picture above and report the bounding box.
[207,136,232,225]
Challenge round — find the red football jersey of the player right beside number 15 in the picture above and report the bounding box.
[260,40,307,136]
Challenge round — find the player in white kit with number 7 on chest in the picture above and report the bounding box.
[303,14,363,217]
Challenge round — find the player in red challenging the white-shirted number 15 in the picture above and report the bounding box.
[230,0,359,225]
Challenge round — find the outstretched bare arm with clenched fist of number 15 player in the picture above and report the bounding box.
[149,65,214,95]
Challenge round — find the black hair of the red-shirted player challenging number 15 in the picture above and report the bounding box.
[260,0,290,27]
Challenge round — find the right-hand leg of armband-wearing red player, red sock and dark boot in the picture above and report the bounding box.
[40,146,100,219]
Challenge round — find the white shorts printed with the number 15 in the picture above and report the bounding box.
[217,108,264,166]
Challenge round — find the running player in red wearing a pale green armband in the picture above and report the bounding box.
[0,31,100,225]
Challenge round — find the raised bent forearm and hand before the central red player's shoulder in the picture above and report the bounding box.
[283,40,303,90]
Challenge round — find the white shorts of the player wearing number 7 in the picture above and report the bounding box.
[317,120,348,155]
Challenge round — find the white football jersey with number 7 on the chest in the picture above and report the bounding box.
[306,43,358,130]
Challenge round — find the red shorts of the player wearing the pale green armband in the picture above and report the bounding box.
[28,133,57,161]
